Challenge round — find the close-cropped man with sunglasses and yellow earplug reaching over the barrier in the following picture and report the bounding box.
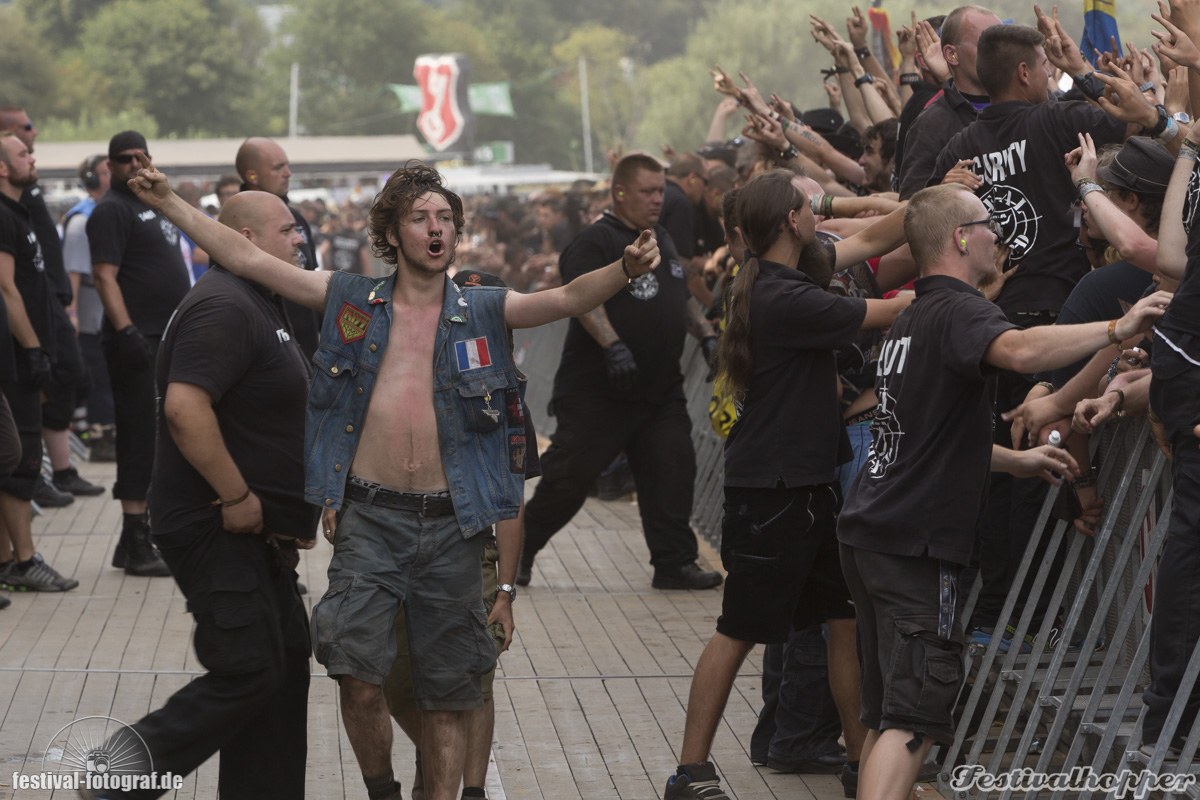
[838,185,1171,800]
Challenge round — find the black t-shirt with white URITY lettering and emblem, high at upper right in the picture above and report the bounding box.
[931,101,1126,313]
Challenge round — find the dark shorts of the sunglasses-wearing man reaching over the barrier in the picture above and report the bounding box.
[841,545,964,744]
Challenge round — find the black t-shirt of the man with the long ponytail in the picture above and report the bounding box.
[725,261,866,488]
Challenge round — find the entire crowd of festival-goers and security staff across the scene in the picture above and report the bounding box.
[0,2,1200,800]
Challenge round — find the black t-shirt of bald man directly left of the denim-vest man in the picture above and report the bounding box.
[150,265,319,539]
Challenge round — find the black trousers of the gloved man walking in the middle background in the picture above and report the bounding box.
[524,395,698,570]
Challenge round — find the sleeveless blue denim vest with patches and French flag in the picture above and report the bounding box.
[305,272,523,537]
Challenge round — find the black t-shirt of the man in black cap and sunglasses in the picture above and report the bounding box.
[88,182,190,336]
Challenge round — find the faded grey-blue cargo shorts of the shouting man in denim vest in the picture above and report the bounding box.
[312,503,496,711]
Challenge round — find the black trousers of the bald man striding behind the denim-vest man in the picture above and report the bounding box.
[117,524,311,800]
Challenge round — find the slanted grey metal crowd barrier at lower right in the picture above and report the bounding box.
[938,420,1200,799]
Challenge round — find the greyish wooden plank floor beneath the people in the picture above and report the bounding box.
[0,464,841,800]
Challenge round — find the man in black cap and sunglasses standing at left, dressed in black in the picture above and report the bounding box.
[88,131,190,576]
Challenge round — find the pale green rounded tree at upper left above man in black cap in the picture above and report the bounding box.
[80,0,265,136]
